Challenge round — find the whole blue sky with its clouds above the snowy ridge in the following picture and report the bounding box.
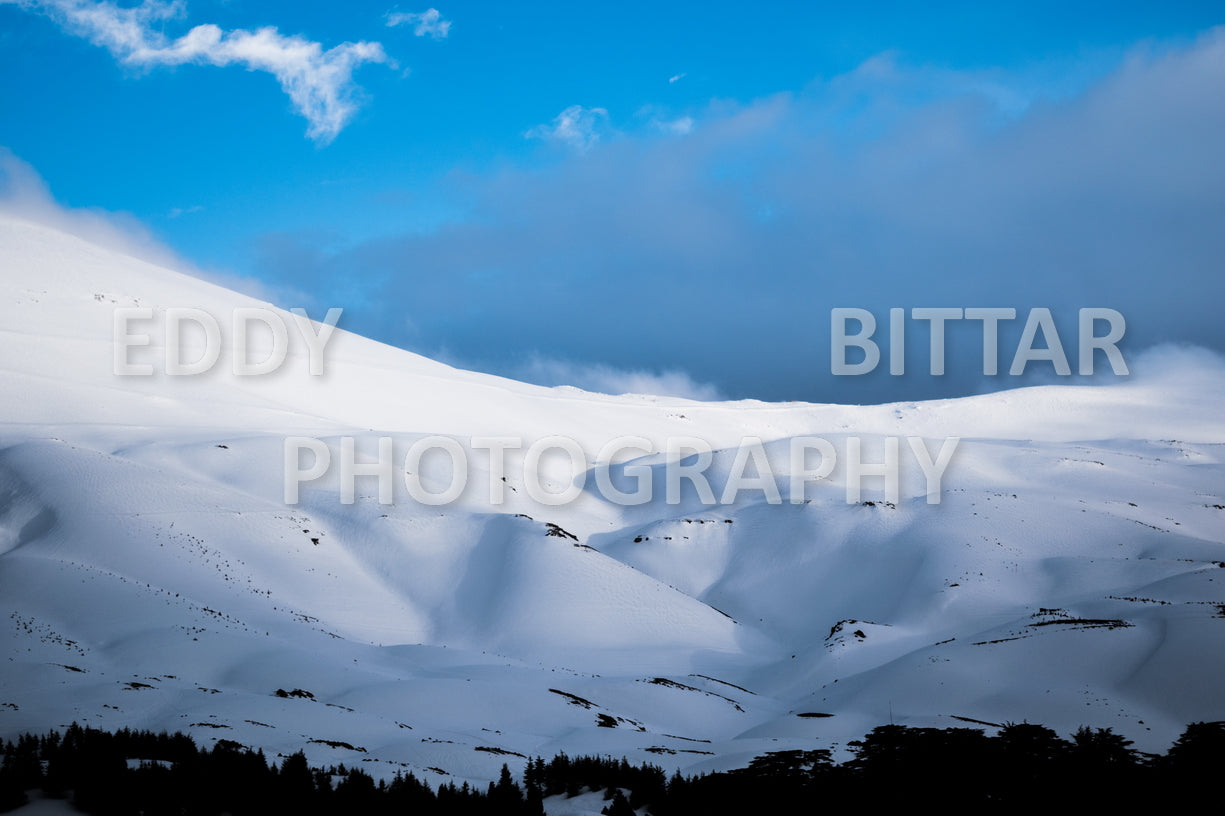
[0,0,1225,402]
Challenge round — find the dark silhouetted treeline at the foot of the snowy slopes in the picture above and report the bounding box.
[0,723,1225,816]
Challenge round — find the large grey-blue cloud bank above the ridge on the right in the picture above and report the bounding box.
[260,29,1225,402]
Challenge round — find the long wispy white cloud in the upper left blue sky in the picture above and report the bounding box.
[7,0,394,145]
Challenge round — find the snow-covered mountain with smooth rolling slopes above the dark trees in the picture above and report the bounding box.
[0,216,1225,782]
